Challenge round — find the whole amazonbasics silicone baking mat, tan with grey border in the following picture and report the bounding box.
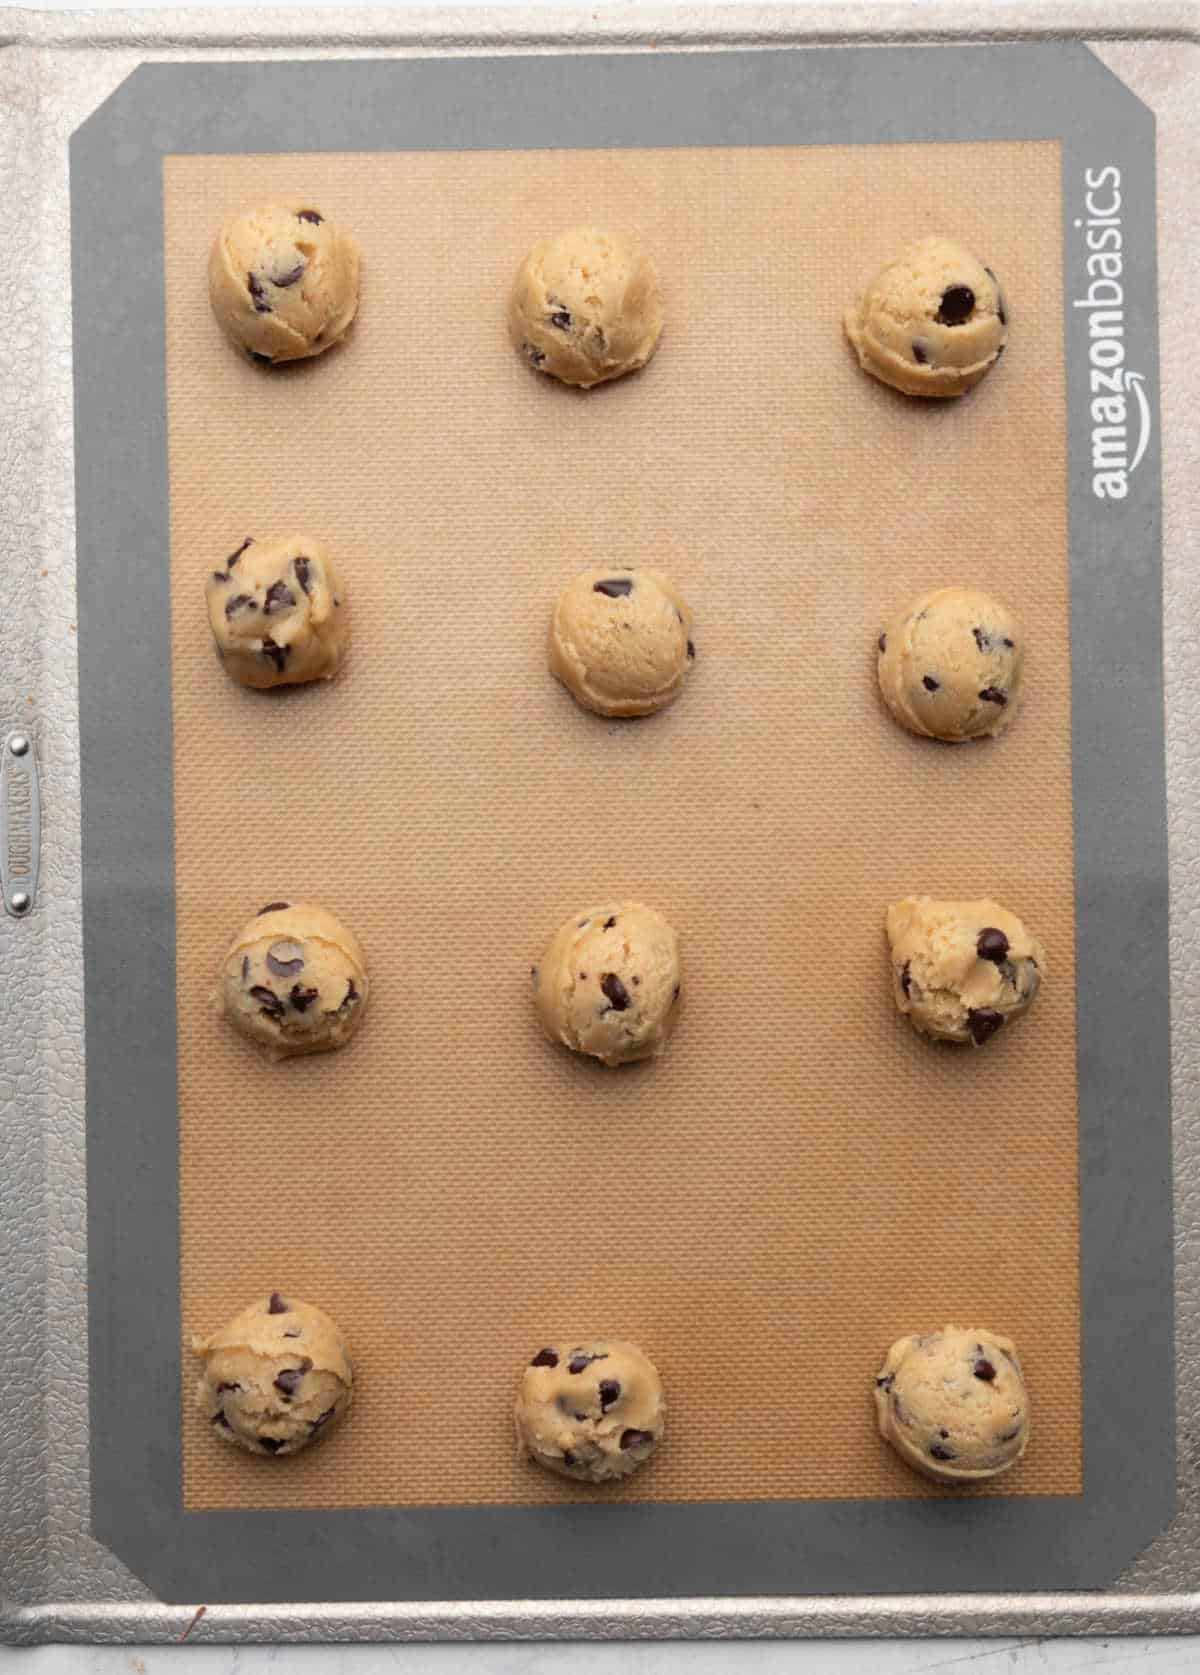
[67,52,1170,1600]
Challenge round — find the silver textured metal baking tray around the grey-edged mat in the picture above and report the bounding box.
[0,3,1200,1643]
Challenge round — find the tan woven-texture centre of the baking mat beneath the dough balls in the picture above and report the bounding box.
[164,144,1081,1508]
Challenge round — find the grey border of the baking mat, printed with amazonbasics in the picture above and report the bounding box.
[70,45,1175,1603]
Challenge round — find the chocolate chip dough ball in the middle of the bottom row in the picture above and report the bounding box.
[513,1338,665,1482]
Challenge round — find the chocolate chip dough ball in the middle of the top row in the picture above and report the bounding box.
[508,226,662,390]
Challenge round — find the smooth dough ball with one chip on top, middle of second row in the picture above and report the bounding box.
[550,570,696,715]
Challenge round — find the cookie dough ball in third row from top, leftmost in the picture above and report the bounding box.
[216,901,370,1059]
